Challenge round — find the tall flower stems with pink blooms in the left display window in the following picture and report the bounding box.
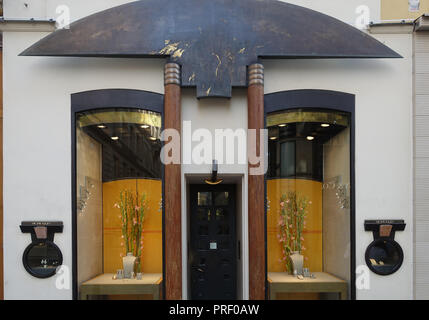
[115,190,148,273]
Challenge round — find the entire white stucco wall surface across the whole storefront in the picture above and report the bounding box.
[3,0,413,299]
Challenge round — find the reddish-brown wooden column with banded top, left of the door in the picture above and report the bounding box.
[164,63,182,300]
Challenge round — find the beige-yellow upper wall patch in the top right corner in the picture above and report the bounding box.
[381,0,429,20]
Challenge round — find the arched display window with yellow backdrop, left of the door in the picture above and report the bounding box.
[76,108,162,300]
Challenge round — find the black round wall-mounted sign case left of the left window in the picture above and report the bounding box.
[20,221,63,279]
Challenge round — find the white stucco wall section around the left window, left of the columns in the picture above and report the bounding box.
[3,32,164,299]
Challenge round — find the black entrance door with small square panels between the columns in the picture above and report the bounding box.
[189,185,237,300]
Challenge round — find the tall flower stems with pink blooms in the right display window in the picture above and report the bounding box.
[278,191,311,273]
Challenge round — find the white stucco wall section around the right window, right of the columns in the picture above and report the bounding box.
[264,34,413,300]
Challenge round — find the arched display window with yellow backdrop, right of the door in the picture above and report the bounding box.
[266,108,352,299]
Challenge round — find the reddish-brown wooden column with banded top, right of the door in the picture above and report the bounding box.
[247,64,266,300]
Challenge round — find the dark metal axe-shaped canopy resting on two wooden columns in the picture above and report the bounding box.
[21,0,401,98]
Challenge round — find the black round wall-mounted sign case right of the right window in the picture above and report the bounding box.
[365,220,406,276]
